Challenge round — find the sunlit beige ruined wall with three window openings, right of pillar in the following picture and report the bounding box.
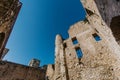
[64,14,120,80]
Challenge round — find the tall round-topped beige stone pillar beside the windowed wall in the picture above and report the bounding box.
[54,35,67,80]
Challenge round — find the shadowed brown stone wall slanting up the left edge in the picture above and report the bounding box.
[0,0,22,58]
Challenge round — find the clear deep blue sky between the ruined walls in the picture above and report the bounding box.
[4,0,85,66]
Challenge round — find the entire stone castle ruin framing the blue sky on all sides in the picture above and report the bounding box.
[0,0,120,80]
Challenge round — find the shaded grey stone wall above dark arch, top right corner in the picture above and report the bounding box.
[95,0,120,26]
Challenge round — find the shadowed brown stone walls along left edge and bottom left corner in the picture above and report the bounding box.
[0,0,46,80]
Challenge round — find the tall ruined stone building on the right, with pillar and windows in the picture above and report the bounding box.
[46,0,120,80]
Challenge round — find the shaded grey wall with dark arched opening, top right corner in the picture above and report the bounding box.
[95,0,120,44]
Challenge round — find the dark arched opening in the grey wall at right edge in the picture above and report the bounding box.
[110,16,120,41]
